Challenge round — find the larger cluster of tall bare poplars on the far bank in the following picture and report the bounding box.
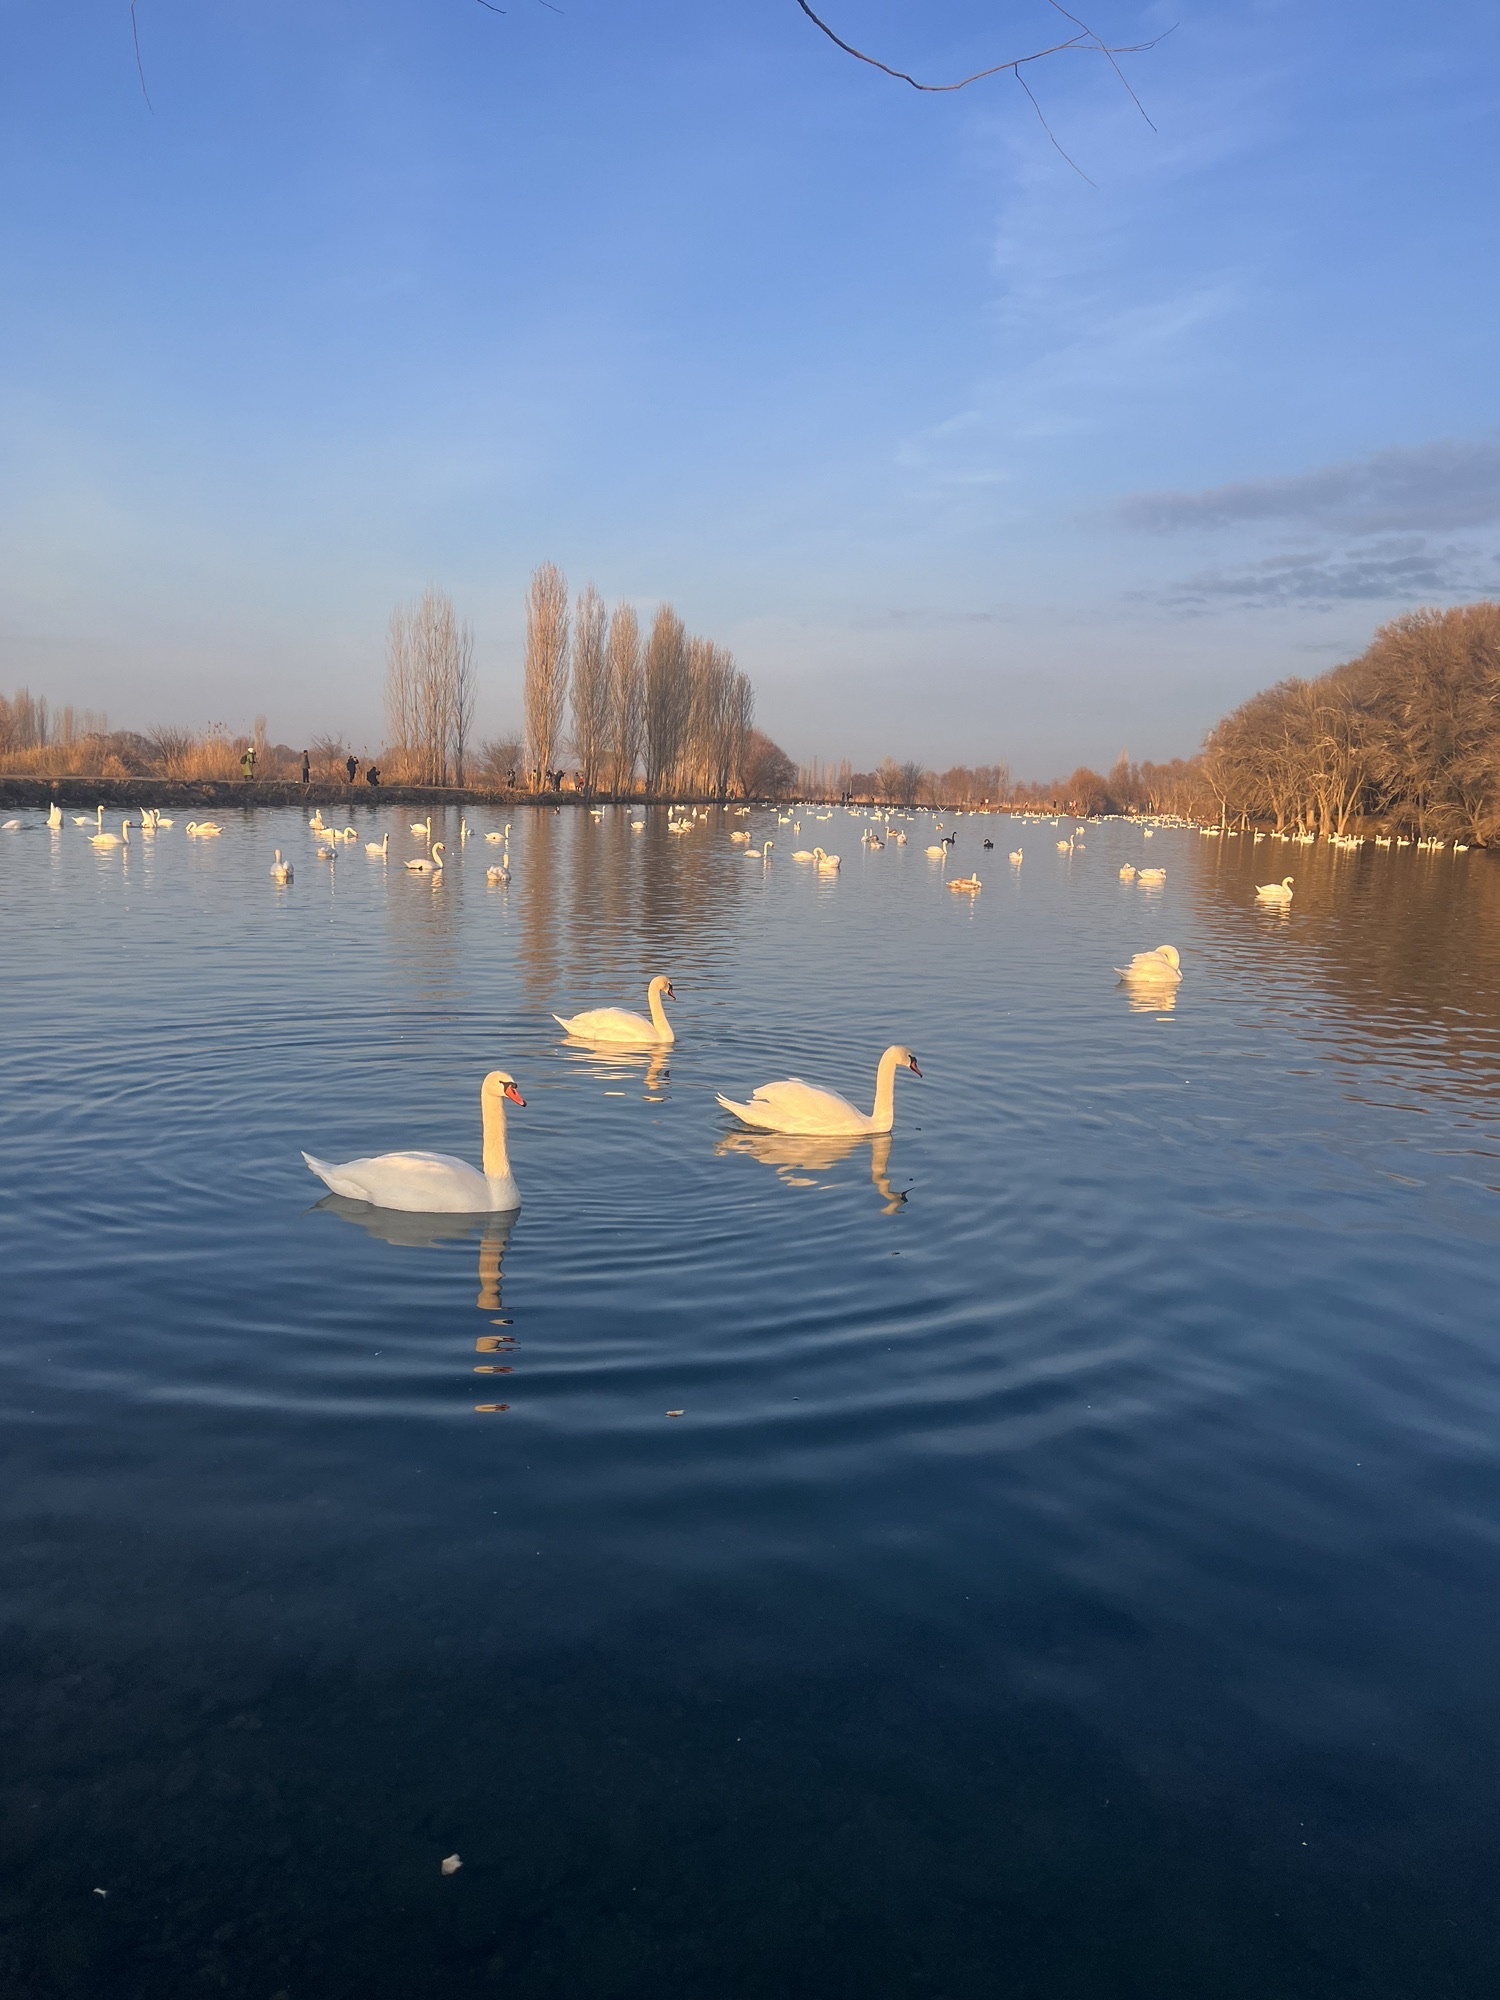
[524,562,756,798]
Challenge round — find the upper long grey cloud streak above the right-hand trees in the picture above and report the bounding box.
[1116,434,1500,536]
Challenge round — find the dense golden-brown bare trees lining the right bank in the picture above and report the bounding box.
[1200,602,1500,842]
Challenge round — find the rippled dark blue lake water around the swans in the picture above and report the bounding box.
[0,810,1500,2000]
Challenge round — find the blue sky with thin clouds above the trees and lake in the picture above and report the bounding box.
[0,0,1500,776]
